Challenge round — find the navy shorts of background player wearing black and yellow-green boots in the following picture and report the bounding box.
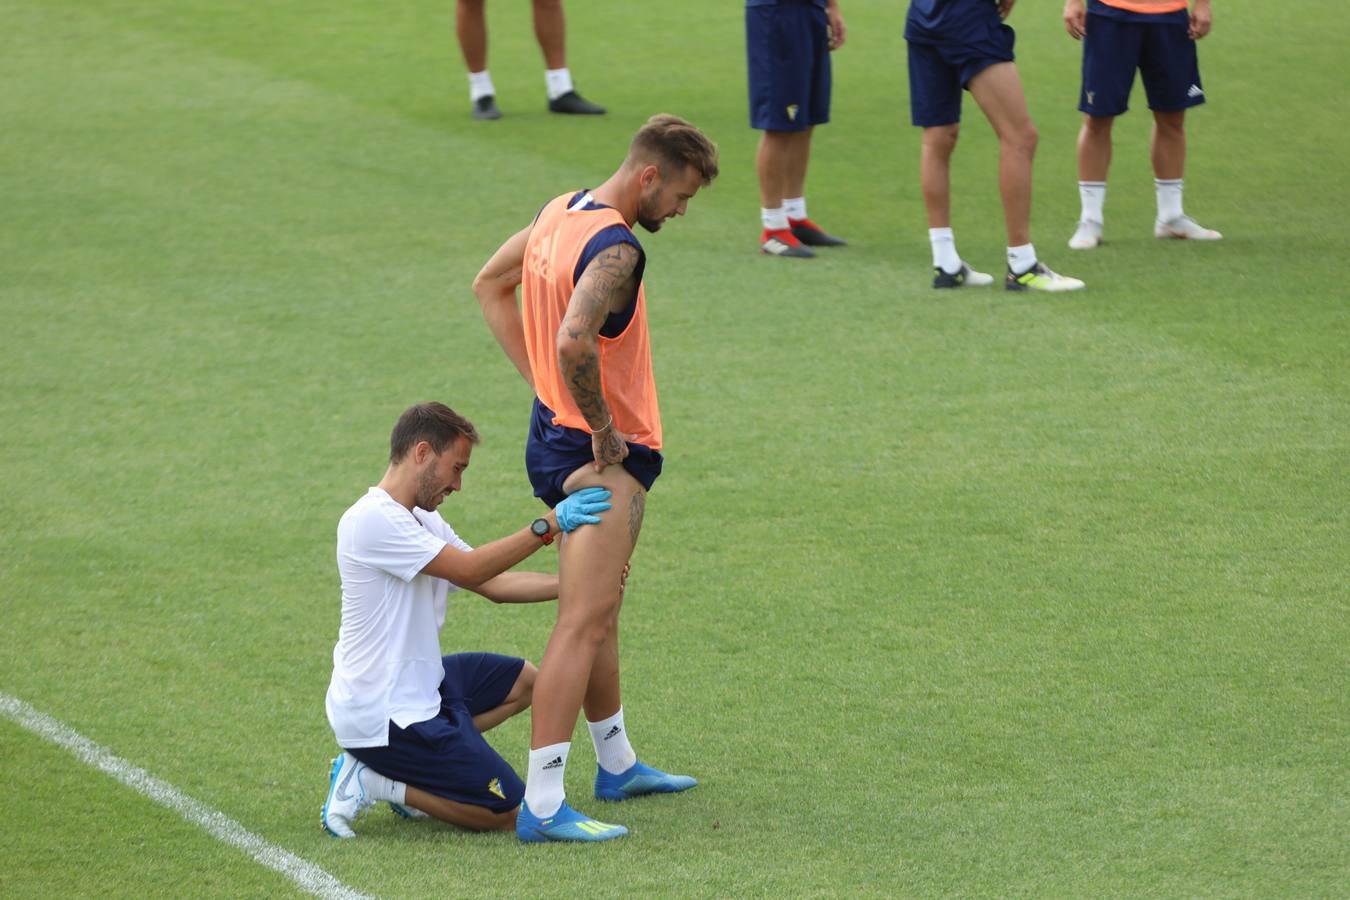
[905,3,1017,128]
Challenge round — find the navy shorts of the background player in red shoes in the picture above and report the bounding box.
[745,0,830,131]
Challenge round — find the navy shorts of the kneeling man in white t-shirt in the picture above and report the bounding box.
[347,653,525,812]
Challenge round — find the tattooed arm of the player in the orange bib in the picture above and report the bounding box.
[558,243,641,428]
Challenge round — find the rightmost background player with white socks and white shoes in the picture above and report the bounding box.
[1064,0,1223,250]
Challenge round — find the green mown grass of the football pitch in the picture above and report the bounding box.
[0,0,1350,897]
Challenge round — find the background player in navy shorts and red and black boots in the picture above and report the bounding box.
[745,0,845,258]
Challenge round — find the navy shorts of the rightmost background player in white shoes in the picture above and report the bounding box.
[1079,0,1204,116]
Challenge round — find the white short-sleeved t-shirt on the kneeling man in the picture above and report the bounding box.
[325,487,473,748]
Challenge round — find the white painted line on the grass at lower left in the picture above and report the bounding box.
[0,692,366,900]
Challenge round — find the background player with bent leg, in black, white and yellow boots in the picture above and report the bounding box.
[905,0,1083,291]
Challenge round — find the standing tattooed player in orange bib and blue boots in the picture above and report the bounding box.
[474,115,717,842]
